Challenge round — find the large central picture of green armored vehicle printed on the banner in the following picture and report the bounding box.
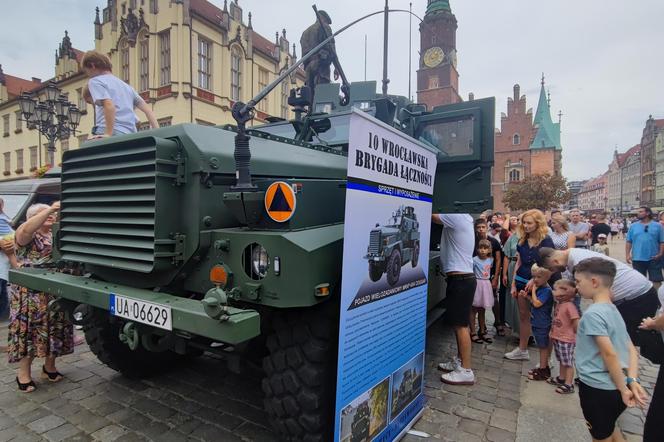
[364,206,420,286]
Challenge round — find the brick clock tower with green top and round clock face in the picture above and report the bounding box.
[417,0,462,110]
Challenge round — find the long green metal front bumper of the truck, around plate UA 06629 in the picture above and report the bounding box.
[9,268,260,344]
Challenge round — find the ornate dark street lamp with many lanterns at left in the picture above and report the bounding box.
[18,81,81,167]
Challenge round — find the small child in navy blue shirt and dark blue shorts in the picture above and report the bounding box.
[521,264,553,381]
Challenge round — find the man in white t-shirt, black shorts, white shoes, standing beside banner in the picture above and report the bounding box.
[431,213,477,385]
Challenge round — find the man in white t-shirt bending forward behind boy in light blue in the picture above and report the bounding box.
[537,247,659,346]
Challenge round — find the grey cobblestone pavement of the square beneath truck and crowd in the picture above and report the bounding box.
[0,237,658,442]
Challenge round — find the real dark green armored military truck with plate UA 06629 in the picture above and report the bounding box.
[10,5,495,441]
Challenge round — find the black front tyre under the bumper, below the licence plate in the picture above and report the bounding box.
[83,310,186,379]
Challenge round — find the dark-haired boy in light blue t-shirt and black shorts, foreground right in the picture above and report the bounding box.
[574,257,647,441]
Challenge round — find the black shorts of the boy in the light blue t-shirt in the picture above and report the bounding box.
[579,382,627,439]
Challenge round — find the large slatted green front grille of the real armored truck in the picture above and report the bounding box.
[59,142,157,273]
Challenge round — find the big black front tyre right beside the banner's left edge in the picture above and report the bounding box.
[262,301,339,441]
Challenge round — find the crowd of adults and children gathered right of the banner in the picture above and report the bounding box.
[432,207,664,442]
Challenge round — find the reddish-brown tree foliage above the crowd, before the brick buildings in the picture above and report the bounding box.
[503,174,571,210]
